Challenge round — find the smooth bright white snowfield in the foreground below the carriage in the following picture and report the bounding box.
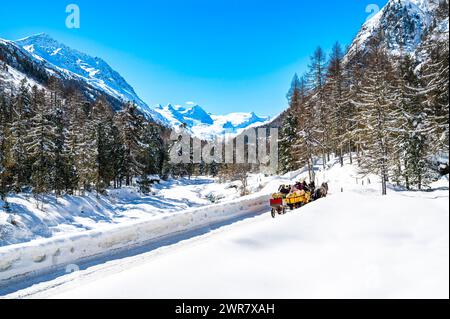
[0,159,449,298]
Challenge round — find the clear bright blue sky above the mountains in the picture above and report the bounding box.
[0,0,387,115]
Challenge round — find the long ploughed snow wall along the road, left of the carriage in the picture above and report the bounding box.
[0,195,268,286]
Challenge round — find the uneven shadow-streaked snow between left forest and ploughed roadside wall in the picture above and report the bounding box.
[0,178,241,247]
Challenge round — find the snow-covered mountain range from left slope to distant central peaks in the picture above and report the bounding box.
[0,33,269,139]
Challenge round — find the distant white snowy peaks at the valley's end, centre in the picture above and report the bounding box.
[154,104,270,139]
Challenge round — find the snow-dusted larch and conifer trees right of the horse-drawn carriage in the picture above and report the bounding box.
[280,32,449,194]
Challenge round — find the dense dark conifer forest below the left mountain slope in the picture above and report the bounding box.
[0,80,170,199]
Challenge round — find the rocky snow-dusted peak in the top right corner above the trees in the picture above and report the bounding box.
[348,0,448,58]
